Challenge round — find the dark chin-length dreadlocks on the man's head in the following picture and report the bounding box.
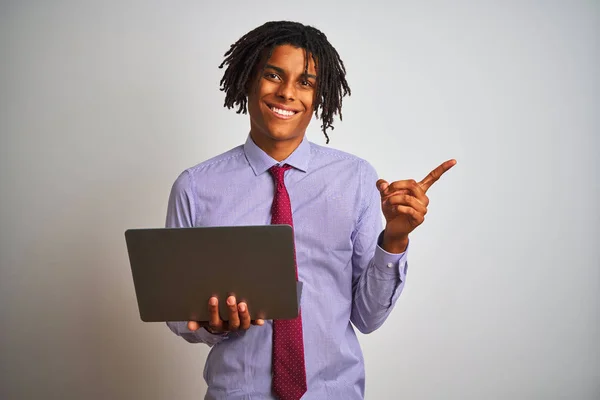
[219,21,350,143]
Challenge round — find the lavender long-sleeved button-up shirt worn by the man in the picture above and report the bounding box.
[167,137,407,400]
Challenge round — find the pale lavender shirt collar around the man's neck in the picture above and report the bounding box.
[244,135,310,175]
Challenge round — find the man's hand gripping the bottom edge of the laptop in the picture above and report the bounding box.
[188,296,265,334]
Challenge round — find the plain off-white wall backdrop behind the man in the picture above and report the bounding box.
[0,0,600,400]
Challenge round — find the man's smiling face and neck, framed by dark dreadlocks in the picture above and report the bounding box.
[248,45,317,161]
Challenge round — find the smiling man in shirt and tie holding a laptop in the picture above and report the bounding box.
[167,21,455,400]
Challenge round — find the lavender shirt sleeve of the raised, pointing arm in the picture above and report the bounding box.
[350,162,408,333]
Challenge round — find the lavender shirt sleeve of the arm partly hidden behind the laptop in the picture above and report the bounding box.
[165,171,227,346]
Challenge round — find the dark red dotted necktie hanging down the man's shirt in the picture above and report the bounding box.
[269,164,306,400]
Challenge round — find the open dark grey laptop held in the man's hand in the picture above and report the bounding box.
[125,225,301,322]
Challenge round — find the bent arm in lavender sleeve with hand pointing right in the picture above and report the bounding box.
[351,160,456,333]
